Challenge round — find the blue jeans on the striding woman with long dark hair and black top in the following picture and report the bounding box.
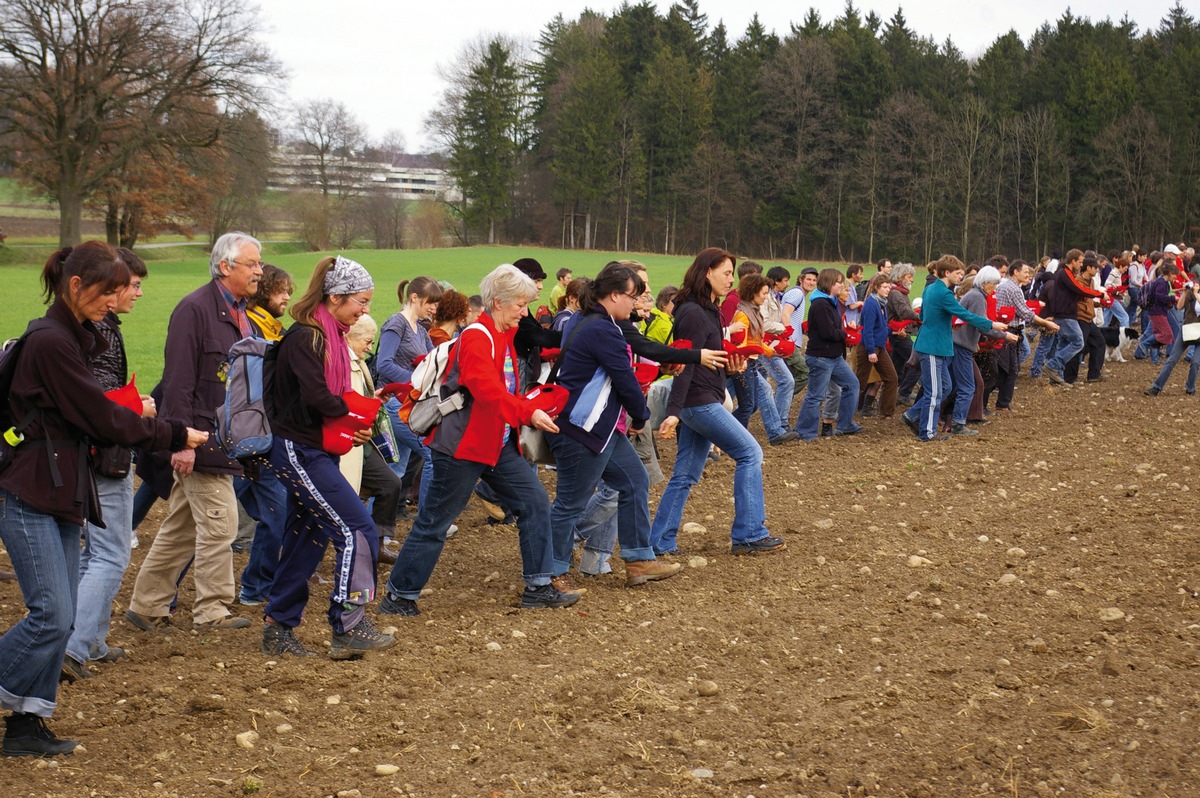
[650,402,769,554]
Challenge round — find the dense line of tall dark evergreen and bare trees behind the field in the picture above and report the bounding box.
[439,0,1200,262]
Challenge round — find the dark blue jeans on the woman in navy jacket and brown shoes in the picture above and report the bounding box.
[546,431,654,576]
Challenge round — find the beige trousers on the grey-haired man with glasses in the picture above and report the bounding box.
[130,472,238,624]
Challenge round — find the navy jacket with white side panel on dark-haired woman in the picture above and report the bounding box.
[557,306,650,454]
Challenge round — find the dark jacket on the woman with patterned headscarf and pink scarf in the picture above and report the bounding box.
[263,323,350,449]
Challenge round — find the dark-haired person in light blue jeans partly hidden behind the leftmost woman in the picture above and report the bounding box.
[62,247,156,682]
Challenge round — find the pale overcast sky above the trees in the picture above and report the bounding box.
[260,0,1187,152]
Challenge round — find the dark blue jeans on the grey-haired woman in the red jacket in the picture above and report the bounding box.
[388,434,554,601]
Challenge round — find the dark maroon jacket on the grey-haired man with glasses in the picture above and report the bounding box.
[158,281,242,476]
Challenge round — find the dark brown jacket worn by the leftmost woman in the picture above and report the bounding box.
[0,300,187,524]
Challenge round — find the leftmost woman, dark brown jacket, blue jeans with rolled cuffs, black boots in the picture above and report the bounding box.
[0,241,209,756]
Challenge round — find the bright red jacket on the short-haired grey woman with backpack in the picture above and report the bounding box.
[425,312,538,466]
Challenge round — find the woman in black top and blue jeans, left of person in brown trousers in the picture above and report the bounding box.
[796,269,863,440]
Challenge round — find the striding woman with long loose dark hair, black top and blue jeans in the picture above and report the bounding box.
[650,247,785,554]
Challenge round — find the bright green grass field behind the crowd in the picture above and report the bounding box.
[0,242,868,390]
